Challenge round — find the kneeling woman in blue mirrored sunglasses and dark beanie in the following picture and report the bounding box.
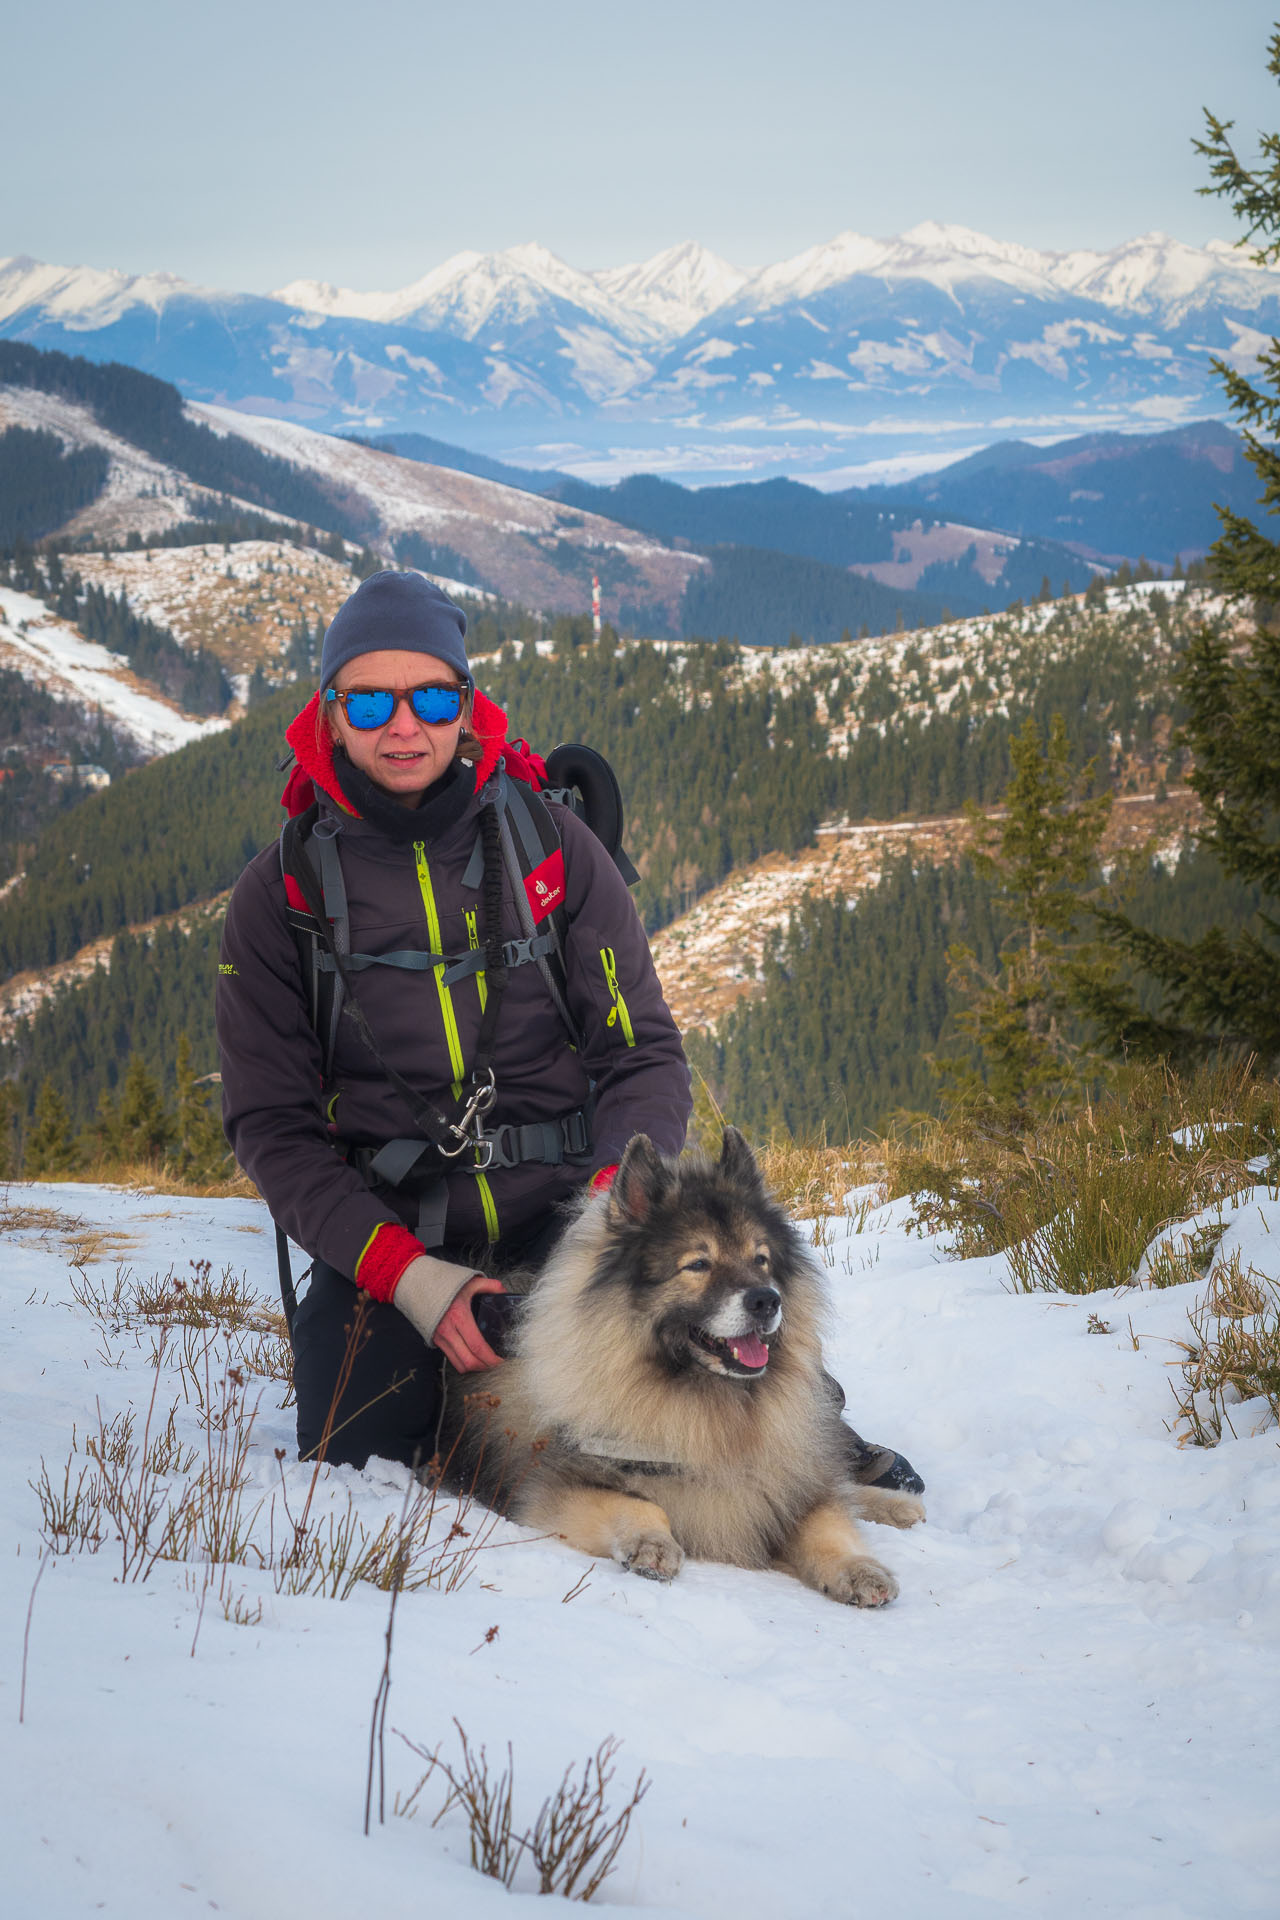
[217,572,691,1467]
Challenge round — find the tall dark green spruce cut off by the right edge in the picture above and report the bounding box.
[1082,29,1280,1066]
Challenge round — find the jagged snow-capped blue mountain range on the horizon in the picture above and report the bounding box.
[0,223,1280,484]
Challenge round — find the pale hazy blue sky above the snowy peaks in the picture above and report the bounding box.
[10,0,1280,292]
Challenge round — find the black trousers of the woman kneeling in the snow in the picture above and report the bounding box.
[292,1210,564,1467]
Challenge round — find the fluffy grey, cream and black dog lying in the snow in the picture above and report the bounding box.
[441,1127,925,1607]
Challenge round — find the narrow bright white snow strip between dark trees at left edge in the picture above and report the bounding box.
[0,588,226,753]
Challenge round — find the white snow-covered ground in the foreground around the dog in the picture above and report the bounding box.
[0,1185,1280,1920]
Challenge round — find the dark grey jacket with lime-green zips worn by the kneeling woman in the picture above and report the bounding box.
[217,730,691,1275]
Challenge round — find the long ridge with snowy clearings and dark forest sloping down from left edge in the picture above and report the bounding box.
[0,340,940,643]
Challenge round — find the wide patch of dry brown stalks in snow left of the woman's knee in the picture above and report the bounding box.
[31,1261,529,1624]
